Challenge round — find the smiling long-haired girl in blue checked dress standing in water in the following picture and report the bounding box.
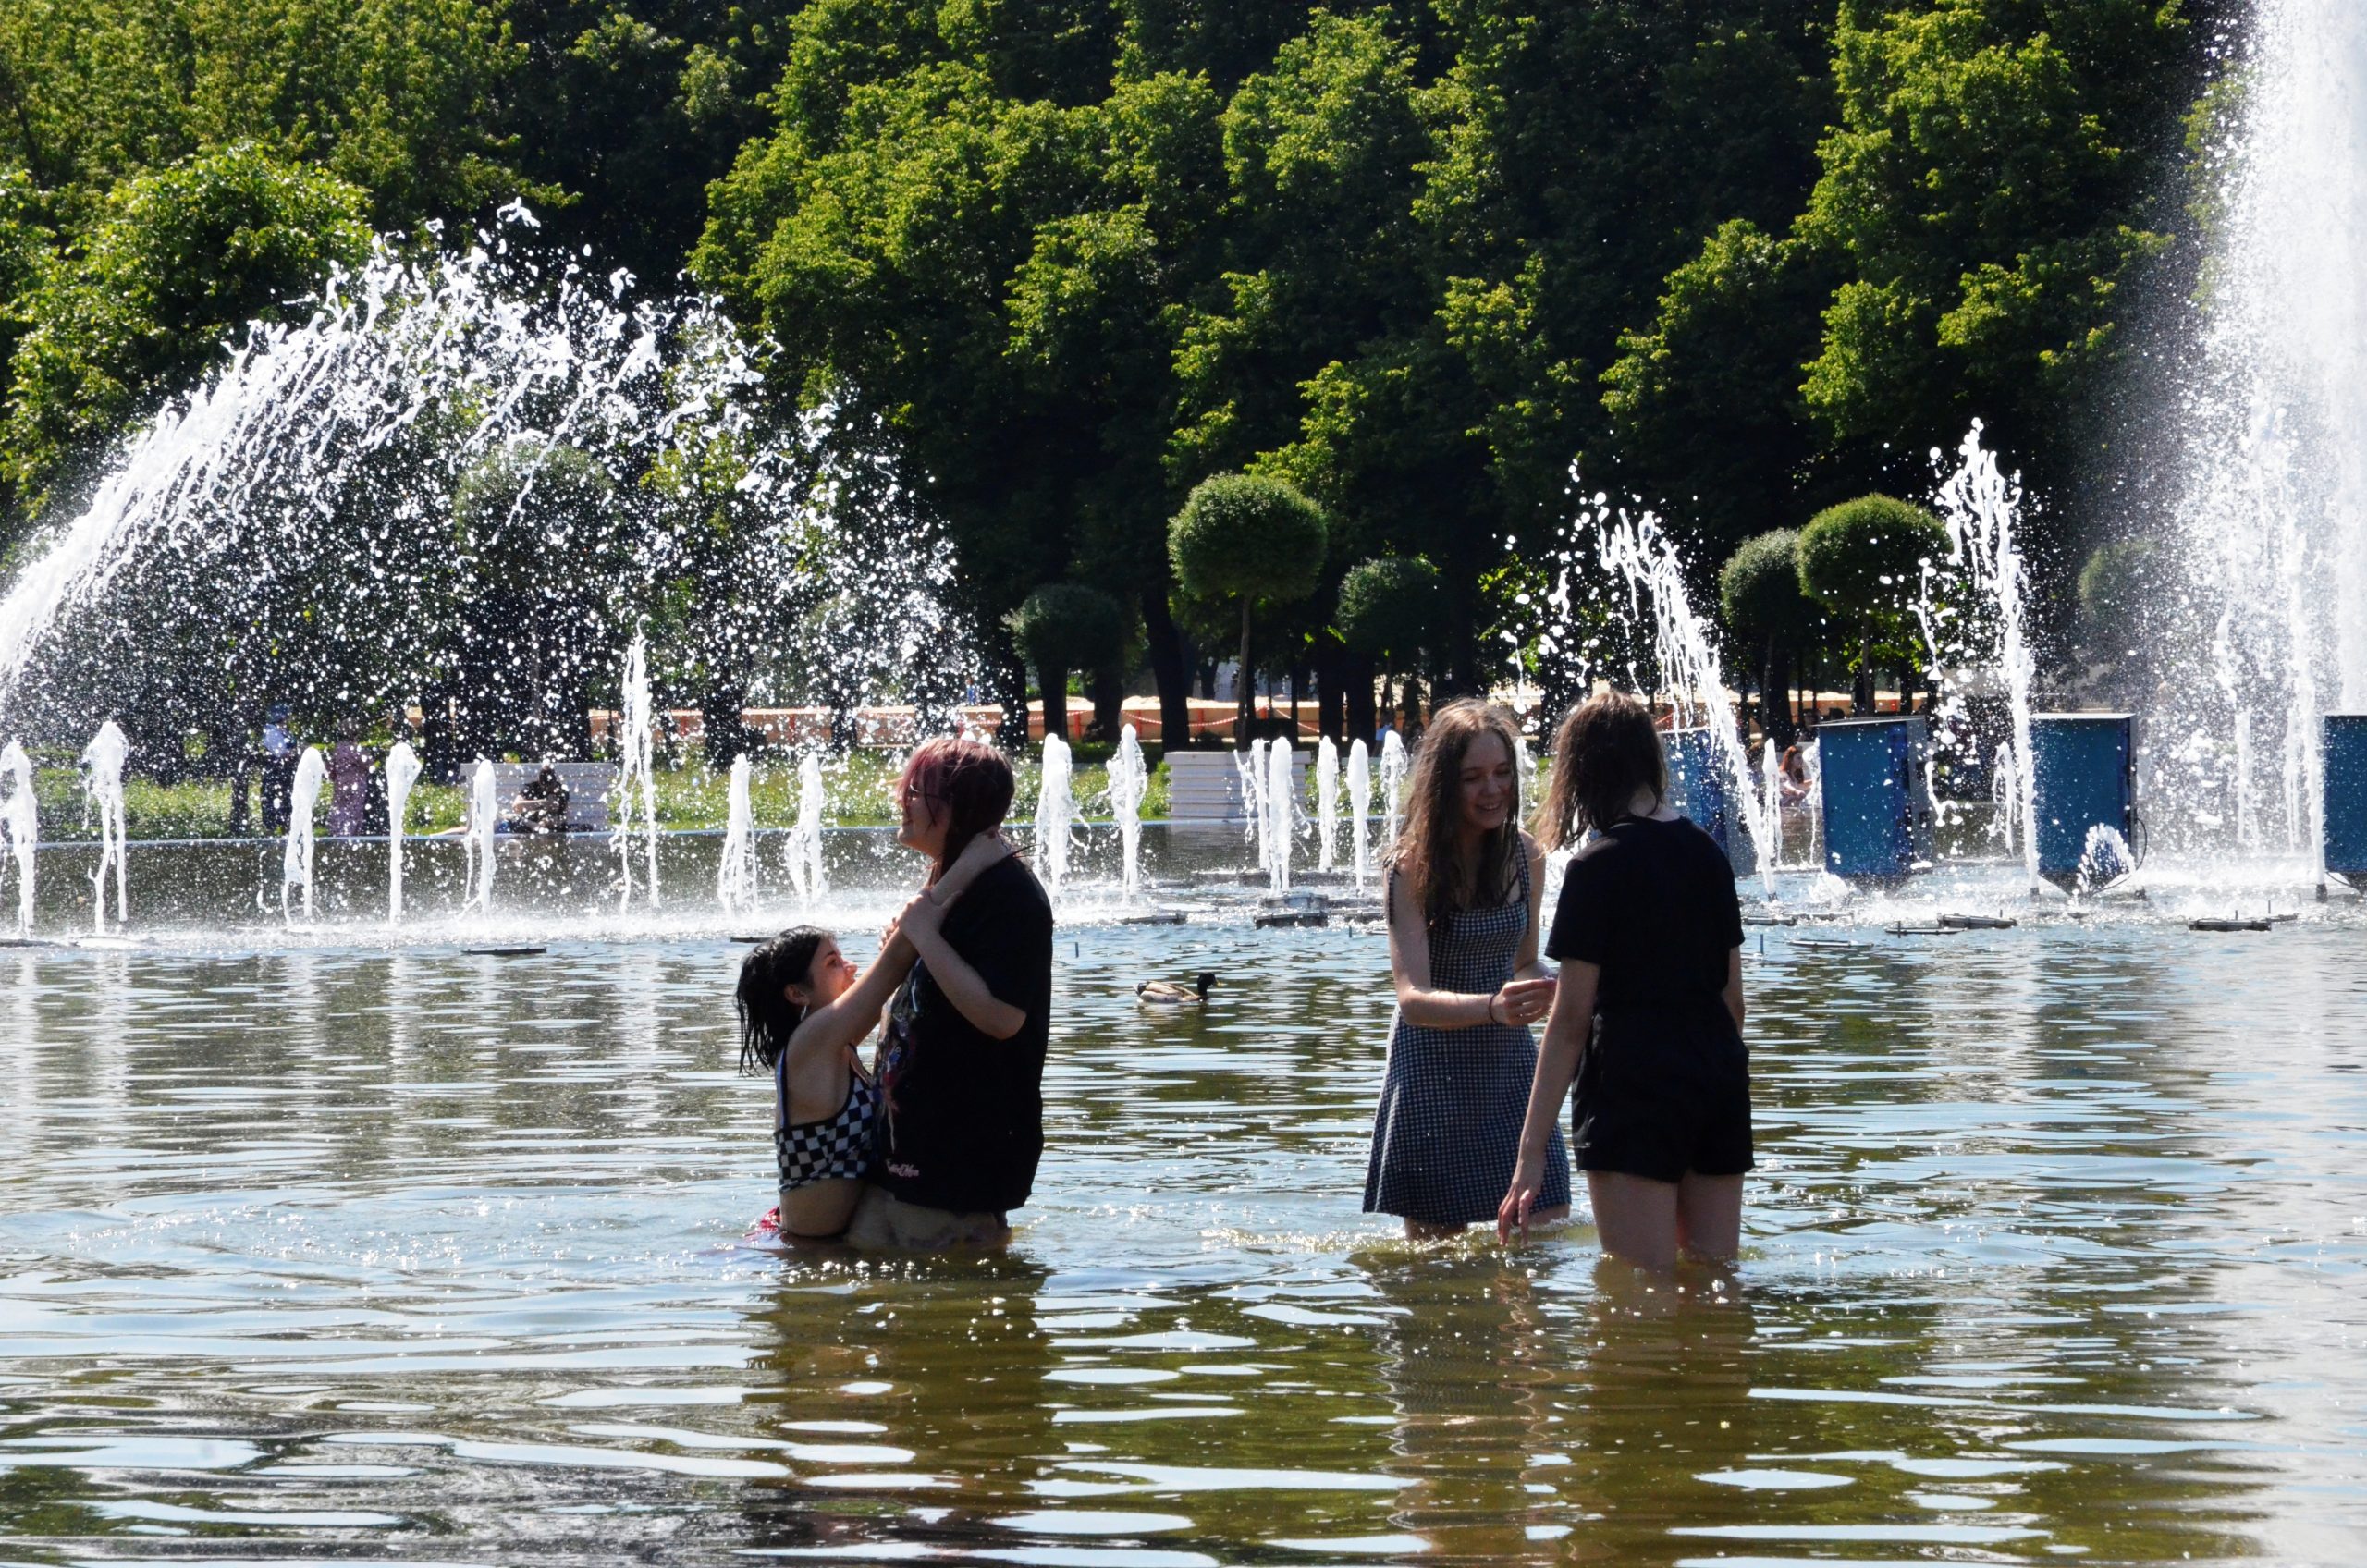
[1364,701,1569,1239]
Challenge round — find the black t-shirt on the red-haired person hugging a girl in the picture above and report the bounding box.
[880,855,1051,1213]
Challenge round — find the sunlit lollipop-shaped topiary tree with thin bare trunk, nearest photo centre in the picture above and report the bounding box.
[1167,473,1328,737]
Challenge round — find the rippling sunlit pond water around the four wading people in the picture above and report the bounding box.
[0,839,2367,1568]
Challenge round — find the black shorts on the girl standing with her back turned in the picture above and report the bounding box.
[1569,1002,1751,1182]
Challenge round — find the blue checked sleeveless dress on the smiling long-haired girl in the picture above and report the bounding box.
[1364,855,1569,1225]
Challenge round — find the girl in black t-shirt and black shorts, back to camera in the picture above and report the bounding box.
[1496,692,1751,1272]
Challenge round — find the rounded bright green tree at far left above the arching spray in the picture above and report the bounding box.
[0,144,369,514]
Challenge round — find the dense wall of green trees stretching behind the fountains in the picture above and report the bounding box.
[0,0,2223,757]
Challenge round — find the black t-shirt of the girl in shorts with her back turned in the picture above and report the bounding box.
[1546,817,1742,1014]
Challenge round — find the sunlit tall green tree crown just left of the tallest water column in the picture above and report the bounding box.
[1799,0,2199,488]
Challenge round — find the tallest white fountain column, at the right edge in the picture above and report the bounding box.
[2158,0,2367,881]
